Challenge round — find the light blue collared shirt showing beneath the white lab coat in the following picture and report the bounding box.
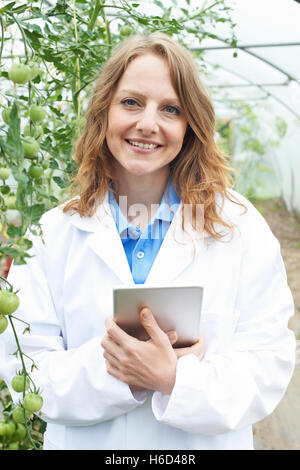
[109,181,180,284]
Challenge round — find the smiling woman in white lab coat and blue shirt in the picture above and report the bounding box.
[0,33,295,450]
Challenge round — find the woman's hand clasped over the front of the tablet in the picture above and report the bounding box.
[101,309,177,394]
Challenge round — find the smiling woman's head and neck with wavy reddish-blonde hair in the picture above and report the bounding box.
[64,33,245,239]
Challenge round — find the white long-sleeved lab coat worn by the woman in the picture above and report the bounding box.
[0,191,296,450]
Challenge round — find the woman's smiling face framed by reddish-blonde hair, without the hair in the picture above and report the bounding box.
[106,54,187,177]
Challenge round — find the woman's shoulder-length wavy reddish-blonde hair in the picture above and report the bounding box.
[63,32,247,240]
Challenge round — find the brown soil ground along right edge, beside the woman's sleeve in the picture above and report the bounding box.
[253,199,300,450]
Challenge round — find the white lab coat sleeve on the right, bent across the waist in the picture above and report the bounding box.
[152,207,296,435]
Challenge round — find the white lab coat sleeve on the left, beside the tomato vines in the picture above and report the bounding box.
[0,229,146,426]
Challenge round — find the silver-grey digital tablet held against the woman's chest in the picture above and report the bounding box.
[113,284,203,348]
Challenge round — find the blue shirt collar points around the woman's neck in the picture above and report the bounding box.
[108,179,180,235]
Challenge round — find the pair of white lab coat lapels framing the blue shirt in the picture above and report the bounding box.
[70,192,227,285]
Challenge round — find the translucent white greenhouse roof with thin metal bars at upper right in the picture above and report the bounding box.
[191,0,300,119]
